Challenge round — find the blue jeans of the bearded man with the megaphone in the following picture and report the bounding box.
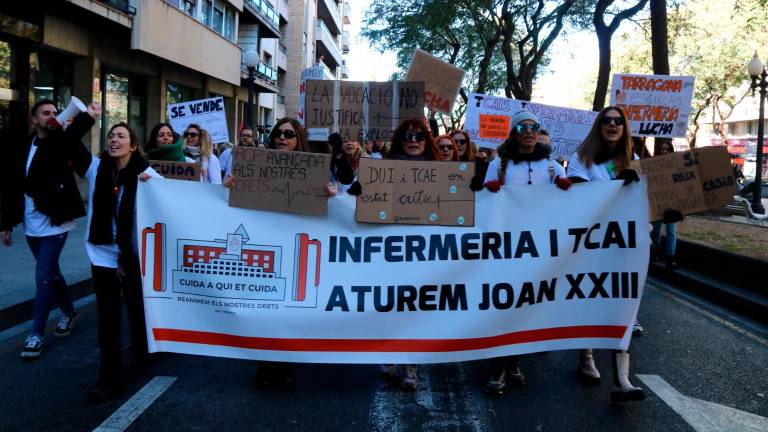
[27,233,75,337]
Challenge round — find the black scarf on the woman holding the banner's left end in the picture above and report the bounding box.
[88,151,149,257]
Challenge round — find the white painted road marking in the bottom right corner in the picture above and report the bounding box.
[637,375,768,432]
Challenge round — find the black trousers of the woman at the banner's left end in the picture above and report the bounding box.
[91,266,147,385]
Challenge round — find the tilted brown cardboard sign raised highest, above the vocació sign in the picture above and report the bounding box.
[405,48,465,114]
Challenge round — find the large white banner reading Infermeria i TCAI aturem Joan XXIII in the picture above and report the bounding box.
[137,179,649,363]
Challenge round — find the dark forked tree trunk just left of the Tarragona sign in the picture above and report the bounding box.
[592,0,648,111]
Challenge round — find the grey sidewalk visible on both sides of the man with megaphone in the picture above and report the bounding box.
[0,217,91,318]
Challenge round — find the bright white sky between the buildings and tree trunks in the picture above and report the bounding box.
[346,0,623,109]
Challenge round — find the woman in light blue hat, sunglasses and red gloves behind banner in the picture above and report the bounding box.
[485,110,571,395]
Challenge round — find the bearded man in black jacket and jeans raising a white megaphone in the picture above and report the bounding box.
[0,99,100,360]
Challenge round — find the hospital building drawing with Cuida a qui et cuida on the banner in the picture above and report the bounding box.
[173,225,286,301]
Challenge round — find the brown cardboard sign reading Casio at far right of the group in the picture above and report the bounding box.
[631,147,737,221]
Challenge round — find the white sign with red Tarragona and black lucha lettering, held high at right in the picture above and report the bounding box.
[611,74,694,138]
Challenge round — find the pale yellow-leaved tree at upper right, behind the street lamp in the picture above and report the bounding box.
[614,0,768,147]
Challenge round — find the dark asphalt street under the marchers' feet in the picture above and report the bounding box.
[0,282,768,432]
